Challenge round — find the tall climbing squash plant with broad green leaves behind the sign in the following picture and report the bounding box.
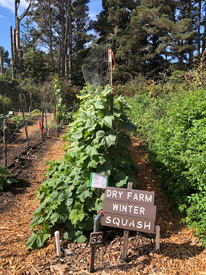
[26,85,138,249]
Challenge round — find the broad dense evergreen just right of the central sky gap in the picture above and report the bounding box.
[102,0,192,82]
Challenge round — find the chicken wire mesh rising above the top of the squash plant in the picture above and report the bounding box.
[82,39,113,88]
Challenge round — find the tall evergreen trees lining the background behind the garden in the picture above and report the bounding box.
[3,0,206,86]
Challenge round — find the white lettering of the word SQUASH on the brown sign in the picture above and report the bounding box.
[105,216,151,230]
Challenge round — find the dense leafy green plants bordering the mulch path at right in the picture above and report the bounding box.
[130,84,206,246]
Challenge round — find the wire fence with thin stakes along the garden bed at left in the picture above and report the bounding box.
[0,105,78,168]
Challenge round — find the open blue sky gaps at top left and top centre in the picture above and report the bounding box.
[0,0,102,56]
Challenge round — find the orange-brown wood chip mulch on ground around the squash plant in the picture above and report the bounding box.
[0,129,206,275]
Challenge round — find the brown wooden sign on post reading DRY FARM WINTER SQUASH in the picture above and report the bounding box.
[102,183,156,260]
